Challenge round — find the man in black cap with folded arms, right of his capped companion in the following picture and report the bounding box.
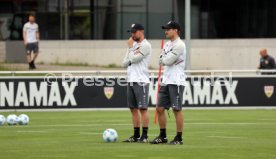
[150,21,186,145]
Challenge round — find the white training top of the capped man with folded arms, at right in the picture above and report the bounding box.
[160,38,186,85]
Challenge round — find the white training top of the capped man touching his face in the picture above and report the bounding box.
[123,39,152,83]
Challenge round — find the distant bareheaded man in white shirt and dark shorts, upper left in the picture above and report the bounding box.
[23,14,39,69]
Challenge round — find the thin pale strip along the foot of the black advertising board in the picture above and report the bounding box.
[0,106,276,112]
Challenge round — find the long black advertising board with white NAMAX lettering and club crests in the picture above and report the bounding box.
[0,76,276,109]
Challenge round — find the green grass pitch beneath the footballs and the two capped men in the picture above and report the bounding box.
[0,110,276,159]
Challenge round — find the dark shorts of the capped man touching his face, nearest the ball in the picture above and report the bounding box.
[127,82,149,109]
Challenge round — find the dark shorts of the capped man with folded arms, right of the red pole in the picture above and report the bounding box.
[158,84,184,111]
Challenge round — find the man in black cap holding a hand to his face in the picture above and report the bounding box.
[123,24,152,143]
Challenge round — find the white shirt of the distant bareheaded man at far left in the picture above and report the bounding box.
[23,22,38,43]
